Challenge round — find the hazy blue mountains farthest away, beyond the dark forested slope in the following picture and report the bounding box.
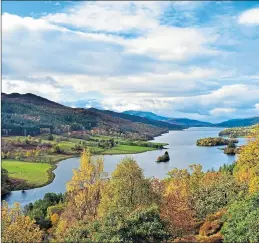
[123,110,212,127]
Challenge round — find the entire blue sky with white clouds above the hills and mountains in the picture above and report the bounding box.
[2,1,259,122]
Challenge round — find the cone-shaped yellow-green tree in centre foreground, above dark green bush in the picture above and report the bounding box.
[99,157,157,215]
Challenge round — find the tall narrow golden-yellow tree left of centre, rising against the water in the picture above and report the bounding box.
[56,149,107,241]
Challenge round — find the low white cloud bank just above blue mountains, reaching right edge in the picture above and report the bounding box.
[99,84,259,121]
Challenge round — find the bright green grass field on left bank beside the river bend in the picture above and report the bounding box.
[2,160,55,187]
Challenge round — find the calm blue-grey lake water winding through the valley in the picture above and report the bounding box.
[2,128,248,206]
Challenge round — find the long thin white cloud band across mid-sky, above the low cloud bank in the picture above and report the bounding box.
[53,67,217,97]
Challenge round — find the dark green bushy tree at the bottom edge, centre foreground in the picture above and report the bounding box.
[93,206,170,243]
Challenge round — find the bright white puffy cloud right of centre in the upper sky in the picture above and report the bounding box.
[125,26,218,60]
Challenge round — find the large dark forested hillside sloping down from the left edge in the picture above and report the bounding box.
[1,93,183,139]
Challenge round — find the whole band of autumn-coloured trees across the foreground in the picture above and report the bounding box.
[2,128,259,243]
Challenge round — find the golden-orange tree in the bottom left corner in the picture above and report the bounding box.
[1,201,42,243]
